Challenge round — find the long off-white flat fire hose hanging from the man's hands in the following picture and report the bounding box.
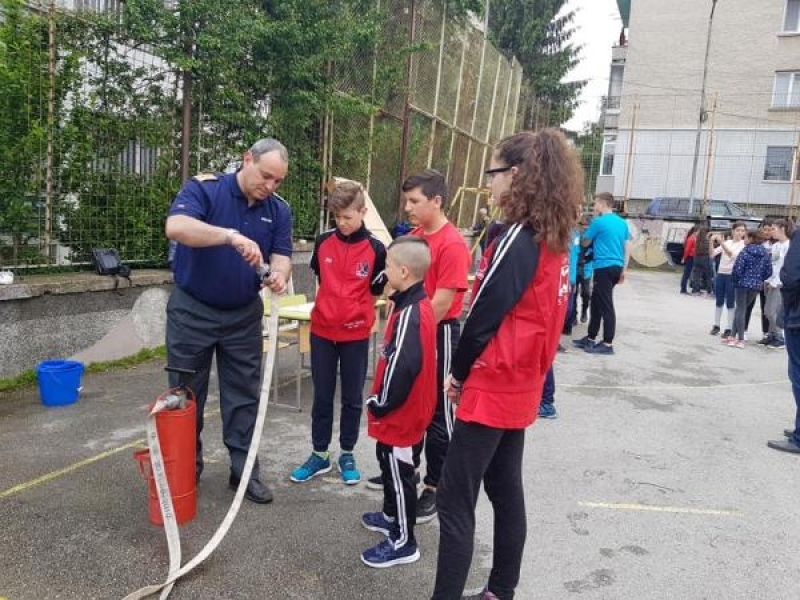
[123,265,279,600]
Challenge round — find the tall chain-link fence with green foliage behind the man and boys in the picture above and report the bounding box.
[0,0,522,269]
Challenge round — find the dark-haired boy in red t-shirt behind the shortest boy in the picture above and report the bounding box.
[402,169,472,523]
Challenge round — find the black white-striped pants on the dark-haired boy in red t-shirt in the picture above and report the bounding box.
[414,319,461,488]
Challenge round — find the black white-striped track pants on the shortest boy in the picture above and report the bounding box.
[375,442,417,549]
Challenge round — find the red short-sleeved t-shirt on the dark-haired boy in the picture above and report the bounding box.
[411,221,472,320]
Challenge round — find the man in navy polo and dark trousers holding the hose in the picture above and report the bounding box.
[166,139,292,503]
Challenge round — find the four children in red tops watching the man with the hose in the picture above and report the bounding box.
[290,129,583,600]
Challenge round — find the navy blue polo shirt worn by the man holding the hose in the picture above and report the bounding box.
[169,173,292,308]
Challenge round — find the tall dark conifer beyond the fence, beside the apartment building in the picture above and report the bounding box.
[489,0,585,128]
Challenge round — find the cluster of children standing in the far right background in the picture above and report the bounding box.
[682,219,793,349]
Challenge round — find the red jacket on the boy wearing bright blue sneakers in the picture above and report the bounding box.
[311,225,386,342]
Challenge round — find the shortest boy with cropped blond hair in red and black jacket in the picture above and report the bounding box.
[361,236,436,568]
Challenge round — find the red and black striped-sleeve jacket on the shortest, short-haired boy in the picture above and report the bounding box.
[366,281,436,448]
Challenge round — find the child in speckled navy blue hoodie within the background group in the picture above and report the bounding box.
[727,231,772,348]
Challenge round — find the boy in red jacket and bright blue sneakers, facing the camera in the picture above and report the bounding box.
[290,181,386,485]
